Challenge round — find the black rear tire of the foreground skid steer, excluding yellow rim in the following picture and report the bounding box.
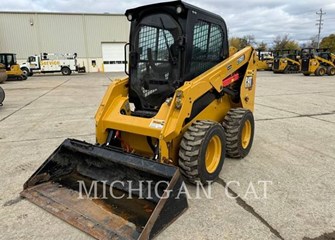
[222,108,255,158]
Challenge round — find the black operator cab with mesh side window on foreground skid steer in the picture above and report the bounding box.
[125,1,229,115]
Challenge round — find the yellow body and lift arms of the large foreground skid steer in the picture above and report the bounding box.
[95,47,257,165]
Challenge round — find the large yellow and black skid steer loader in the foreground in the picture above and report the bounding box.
[21,1,257,239]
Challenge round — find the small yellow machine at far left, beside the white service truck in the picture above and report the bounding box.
[0,53,27,80]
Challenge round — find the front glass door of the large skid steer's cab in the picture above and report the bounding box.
[130,14,181,109]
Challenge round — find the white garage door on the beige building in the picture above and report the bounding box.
[102,43,126,72]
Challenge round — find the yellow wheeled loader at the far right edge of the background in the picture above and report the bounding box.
[301,48,335,76]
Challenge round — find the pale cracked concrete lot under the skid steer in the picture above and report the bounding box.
[0,72,335,240]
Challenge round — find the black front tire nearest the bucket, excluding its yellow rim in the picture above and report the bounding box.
[179,120,226,184]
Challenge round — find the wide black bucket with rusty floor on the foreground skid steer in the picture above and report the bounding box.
[21,139,188,239]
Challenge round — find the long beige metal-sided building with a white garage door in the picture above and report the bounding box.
[0,12,130,72]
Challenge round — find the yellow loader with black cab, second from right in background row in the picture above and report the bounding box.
[272,50,301,73]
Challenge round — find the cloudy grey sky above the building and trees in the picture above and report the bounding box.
[0,0,335,44]
